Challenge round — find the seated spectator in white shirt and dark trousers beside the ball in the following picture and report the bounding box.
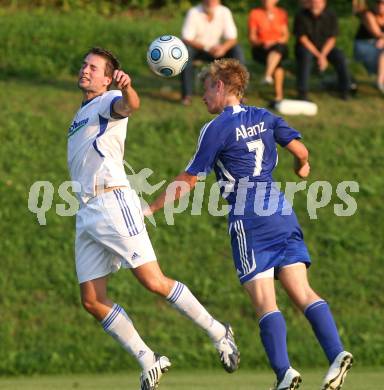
[181,0,244,105]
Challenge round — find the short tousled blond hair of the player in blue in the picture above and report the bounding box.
[200,58,249,99]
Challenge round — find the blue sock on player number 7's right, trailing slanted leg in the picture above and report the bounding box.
[304,300,344,363]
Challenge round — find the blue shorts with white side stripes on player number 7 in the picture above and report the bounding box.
[229,216,311,284]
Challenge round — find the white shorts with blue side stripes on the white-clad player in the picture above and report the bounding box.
[75,188,157,283]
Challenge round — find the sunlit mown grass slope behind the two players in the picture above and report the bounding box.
[0,9,384,374]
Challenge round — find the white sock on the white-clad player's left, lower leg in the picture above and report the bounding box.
[101,303,155,369]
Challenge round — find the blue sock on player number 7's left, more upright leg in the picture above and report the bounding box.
[259,311,290,381]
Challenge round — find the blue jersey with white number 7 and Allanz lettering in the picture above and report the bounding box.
[186,105,301,216]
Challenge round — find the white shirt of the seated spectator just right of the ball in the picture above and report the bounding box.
[181,5,237,51]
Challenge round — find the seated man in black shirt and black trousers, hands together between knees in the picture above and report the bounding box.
[294,0,351,100]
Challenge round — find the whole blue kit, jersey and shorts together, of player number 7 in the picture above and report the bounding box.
[186,105,310,283]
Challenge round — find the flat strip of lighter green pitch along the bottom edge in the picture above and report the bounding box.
[0,369,384,390]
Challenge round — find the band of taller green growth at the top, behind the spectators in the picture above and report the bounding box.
[0,8,357,78]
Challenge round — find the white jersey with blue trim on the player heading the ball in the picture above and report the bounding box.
[68,91,129,203]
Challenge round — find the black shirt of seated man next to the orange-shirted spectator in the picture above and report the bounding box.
[293,8,339,50]
